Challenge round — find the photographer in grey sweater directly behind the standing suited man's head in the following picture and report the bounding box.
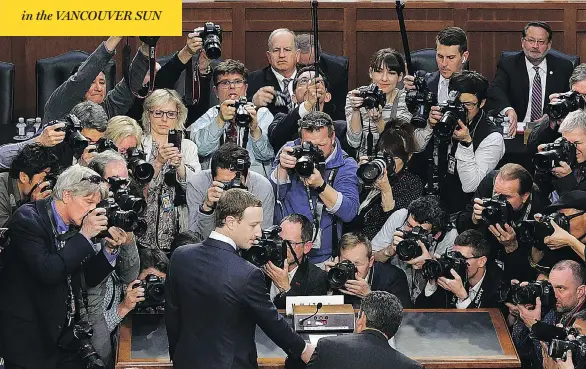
[186,142,275,239]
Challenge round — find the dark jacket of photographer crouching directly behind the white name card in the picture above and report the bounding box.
[267,258,328,309]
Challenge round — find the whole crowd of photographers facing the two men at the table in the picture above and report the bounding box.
[0,22,586,368]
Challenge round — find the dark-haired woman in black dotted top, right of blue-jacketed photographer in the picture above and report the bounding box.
[346,120,423,239]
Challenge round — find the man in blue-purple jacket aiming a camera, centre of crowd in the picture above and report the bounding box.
[270,112,359,264]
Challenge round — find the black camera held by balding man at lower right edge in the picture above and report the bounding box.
[498,281,556,309]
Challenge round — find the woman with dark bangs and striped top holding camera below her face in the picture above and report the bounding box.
[346,49,411,155]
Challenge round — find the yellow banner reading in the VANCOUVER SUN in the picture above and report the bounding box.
[0,0,182,36]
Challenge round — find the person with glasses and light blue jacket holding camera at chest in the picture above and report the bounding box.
[190,59,275,177]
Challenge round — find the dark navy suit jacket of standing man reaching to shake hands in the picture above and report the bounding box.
[165,238,305,369]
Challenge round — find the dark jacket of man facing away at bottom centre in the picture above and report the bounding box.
[307,329,423,369]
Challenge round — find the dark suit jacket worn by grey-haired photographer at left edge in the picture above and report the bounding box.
[0,197,112,368]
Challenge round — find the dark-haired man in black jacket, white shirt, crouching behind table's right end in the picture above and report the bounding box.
[415,230,503,309]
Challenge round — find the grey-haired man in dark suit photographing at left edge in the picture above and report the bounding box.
[0,165,116,369]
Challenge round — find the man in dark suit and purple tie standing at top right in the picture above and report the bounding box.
[488,22,574,135]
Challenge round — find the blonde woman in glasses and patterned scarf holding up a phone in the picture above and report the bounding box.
[138,89,201,253]
